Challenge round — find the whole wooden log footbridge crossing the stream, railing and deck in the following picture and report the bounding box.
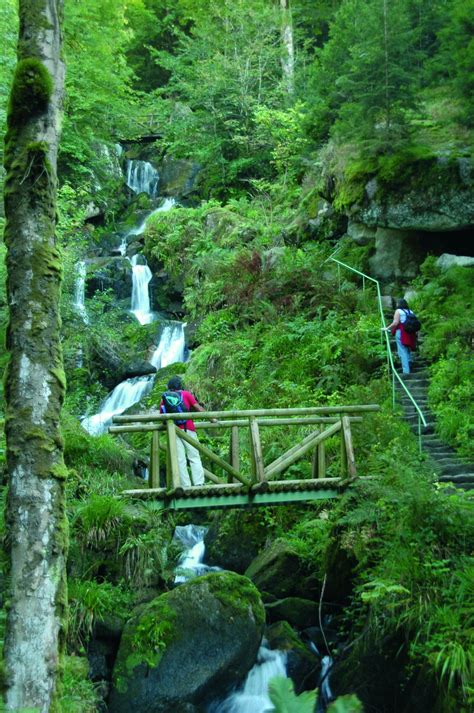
[109,404,379,510]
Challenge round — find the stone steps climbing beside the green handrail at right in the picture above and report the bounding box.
[394,355,474,490]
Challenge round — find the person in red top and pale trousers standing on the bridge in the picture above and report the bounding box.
[160,376,205,488]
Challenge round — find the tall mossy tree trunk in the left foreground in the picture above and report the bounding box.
[5,0,67,711]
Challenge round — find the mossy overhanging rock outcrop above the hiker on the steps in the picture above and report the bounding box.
[316,157,474,281]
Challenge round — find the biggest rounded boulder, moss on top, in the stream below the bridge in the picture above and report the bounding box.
[109,572,265,713]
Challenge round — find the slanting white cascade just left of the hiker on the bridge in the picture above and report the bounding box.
[81,375,154,436]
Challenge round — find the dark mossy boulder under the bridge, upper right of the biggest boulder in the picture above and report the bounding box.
[245,540,308,598]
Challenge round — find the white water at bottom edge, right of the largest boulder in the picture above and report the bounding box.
[207,641,286,713]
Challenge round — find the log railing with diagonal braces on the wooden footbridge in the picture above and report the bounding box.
[109,404,379,490]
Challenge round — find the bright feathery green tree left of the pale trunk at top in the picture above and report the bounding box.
[148,0,282,195]
